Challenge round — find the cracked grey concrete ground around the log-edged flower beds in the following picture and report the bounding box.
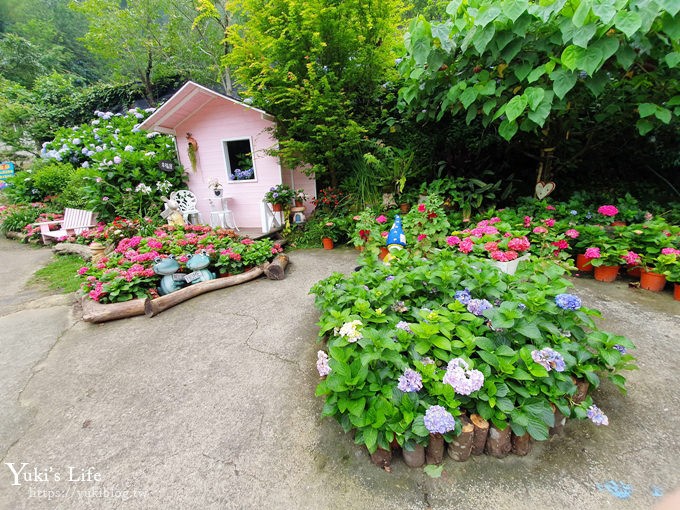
[0,239,680,510]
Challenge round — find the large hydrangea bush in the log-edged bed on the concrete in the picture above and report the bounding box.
[311,249,635,452]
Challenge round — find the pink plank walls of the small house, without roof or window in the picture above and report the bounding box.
[175,98,286,228]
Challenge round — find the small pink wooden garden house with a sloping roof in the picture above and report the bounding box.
[140,81,316,232]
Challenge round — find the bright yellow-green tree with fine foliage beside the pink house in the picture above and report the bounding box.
[225,0,402,183]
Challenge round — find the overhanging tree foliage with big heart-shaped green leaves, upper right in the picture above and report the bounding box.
[400,0,680,140]
